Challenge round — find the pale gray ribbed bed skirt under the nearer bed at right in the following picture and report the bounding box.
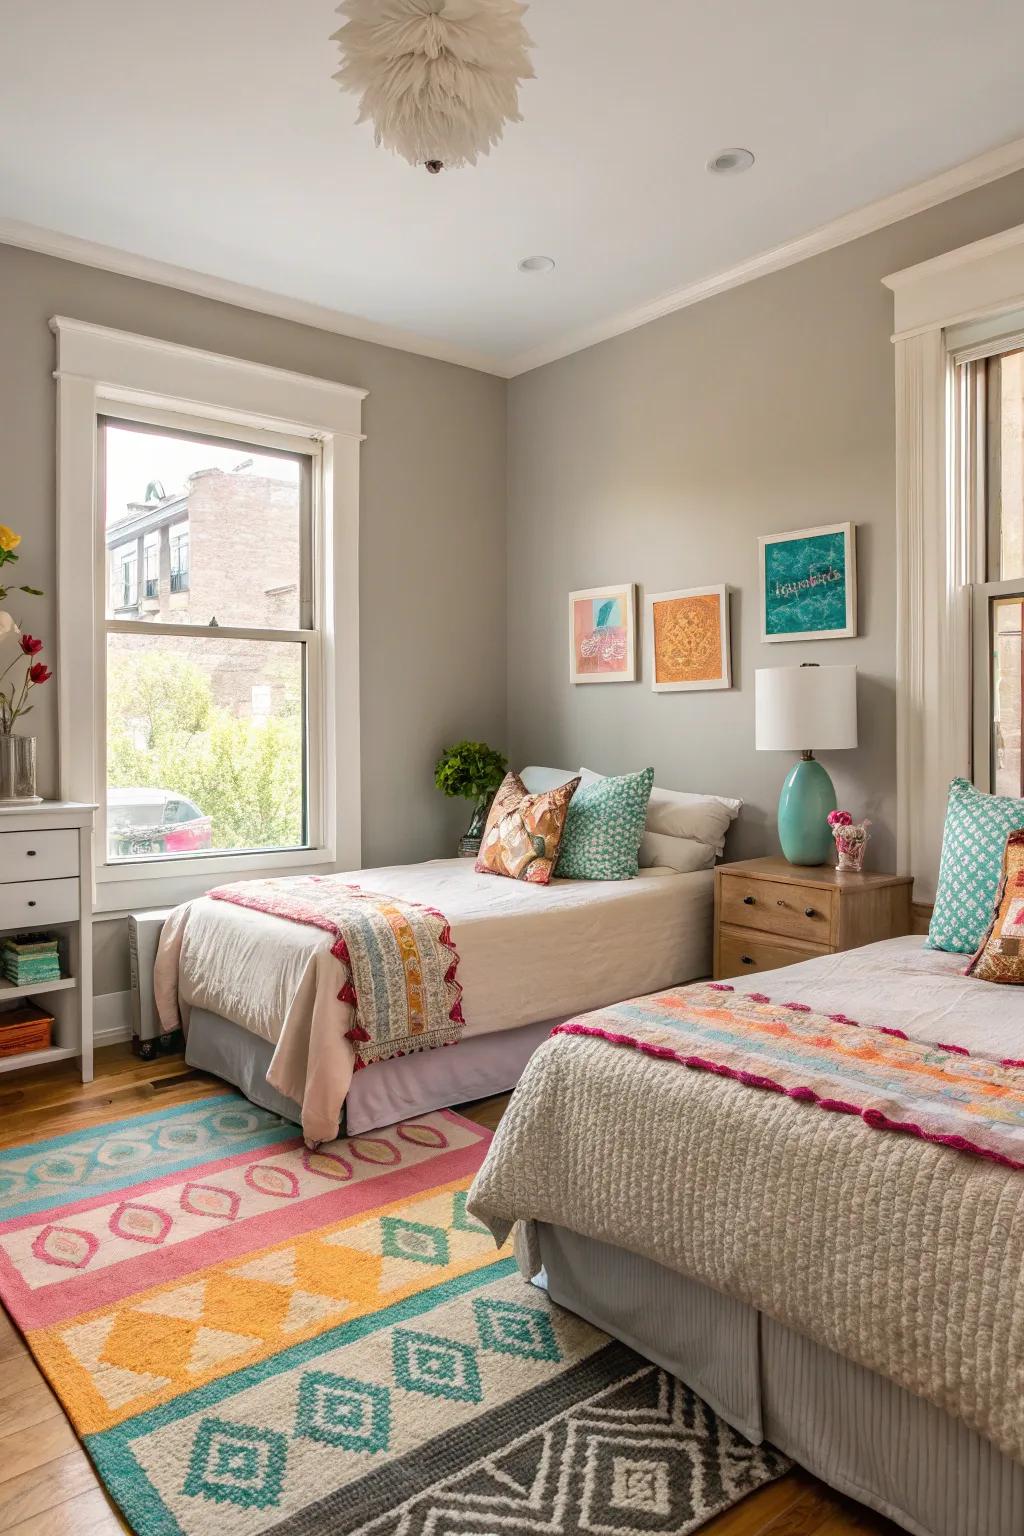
[537,1223,1024,1536]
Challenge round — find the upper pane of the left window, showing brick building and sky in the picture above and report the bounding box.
[101,421,309,630]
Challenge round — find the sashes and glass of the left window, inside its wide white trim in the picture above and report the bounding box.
[97,414,321,865]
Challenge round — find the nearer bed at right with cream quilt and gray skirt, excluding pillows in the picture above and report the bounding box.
[470,937,1024,1536]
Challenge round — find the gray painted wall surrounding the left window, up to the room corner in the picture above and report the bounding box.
[0,246,507,994]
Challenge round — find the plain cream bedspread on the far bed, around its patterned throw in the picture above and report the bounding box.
[155,859,714,1141]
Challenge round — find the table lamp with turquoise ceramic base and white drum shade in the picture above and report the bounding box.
[754,662,857,865]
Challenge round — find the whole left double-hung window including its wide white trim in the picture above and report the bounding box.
[51,318,365,912]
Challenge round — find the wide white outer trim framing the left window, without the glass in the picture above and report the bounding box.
[51,315,367,912]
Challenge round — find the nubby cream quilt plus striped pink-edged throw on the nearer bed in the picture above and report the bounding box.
[470,978,1024,1461]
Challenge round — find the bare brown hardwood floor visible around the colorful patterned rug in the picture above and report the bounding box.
[0,1046,900,1536]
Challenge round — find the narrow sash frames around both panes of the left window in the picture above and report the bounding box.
[95,401,320,882]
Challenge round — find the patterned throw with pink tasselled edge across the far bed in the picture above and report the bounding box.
[209,876,465,1068]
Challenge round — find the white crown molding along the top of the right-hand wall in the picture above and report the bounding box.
[505,138,1024,378]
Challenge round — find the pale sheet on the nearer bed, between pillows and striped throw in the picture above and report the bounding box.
[731,935,1024,1060]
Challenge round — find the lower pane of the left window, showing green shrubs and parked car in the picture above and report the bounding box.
[107,634,307,862]
